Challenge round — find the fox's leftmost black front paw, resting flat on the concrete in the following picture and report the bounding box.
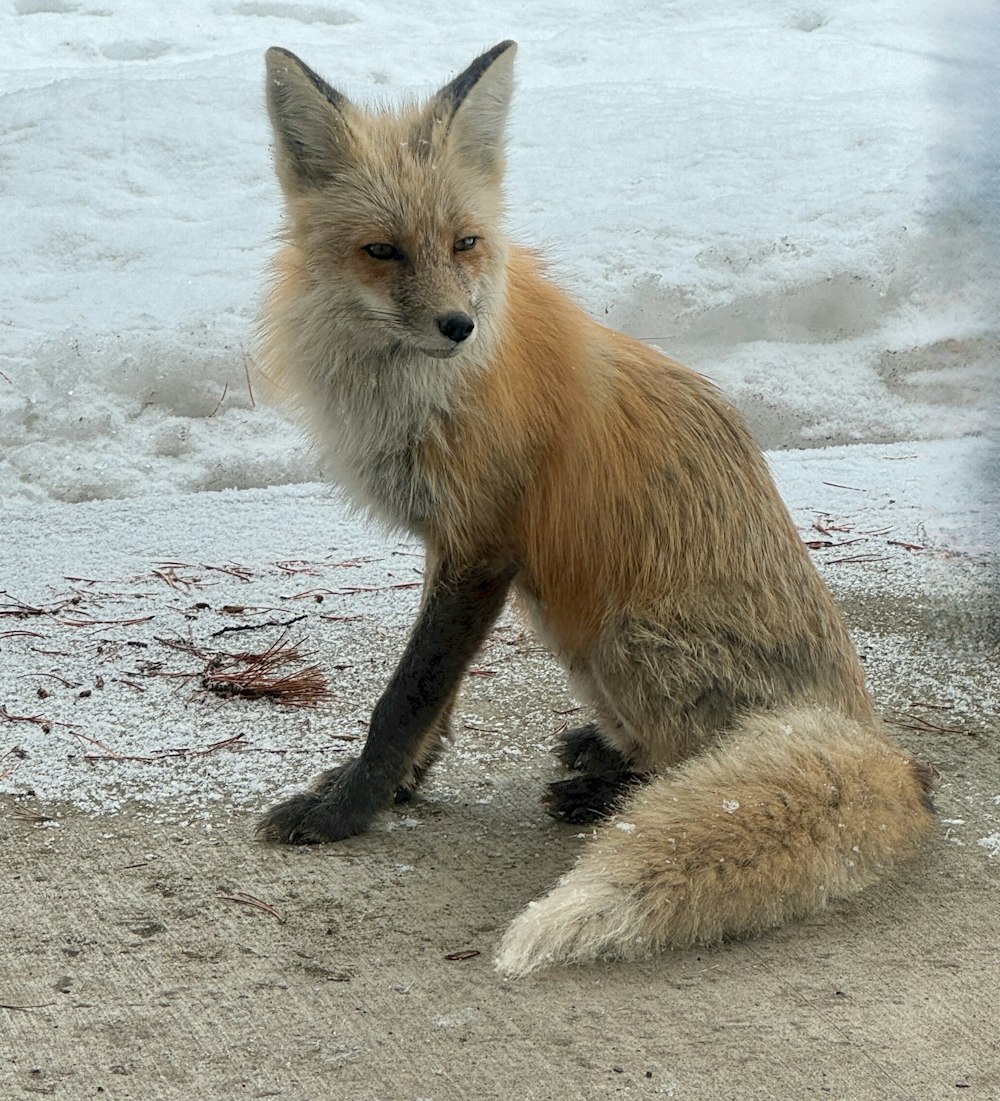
[256,761,379,844]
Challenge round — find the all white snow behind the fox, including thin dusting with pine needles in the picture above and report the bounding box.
[0,0,1000,832]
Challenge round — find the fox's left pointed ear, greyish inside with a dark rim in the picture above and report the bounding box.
[265,46,350,196]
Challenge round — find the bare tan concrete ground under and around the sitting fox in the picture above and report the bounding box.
[0,510,1000,1101]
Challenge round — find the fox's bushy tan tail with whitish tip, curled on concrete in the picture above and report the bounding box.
[497,708,934,977]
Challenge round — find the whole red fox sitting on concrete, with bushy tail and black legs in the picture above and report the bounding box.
[259,42,934,975]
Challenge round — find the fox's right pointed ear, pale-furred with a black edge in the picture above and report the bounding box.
[431,40,518,176]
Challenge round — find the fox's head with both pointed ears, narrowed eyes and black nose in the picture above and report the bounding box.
[267,42,517,359]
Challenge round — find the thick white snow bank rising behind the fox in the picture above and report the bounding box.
[0,0,1000,503]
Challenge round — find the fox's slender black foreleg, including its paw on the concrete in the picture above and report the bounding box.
[257,562,517,844]
